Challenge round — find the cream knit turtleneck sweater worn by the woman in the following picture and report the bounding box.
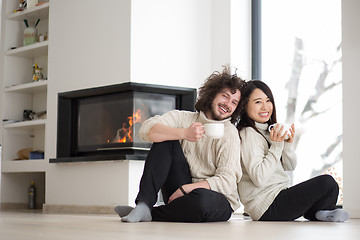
[238,123,297,220]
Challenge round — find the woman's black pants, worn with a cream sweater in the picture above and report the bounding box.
[259,175,339,221]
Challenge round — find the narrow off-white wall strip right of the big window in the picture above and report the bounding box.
[340,0,360,218]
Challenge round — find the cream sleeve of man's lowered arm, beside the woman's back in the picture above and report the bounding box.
[206,124,242,196]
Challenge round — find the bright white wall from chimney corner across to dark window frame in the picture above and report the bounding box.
[131,0,250,88]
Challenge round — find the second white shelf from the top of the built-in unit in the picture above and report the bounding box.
[6,40,49,58]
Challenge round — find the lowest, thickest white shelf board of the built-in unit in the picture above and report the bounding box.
[1,159,48,173]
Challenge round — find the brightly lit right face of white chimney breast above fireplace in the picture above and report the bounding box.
[131,0,213,88]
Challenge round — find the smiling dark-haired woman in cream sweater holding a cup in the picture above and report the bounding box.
[238,80,349,222]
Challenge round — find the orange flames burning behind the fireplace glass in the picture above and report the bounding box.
[112,109,142,143]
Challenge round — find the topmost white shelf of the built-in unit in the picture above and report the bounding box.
[6,2,49,21]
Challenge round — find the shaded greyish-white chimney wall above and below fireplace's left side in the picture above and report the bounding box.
[45,0,131,206]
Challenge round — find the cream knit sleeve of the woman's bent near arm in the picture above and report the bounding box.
[240,127,284,187]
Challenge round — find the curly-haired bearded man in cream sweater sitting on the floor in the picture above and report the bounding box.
[115,67,245,222]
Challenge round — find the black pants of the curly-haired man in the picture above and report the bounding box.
[135,141,233,222]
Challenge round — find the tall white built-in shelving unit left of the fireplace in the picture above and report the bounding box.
[1,0,50,208]
